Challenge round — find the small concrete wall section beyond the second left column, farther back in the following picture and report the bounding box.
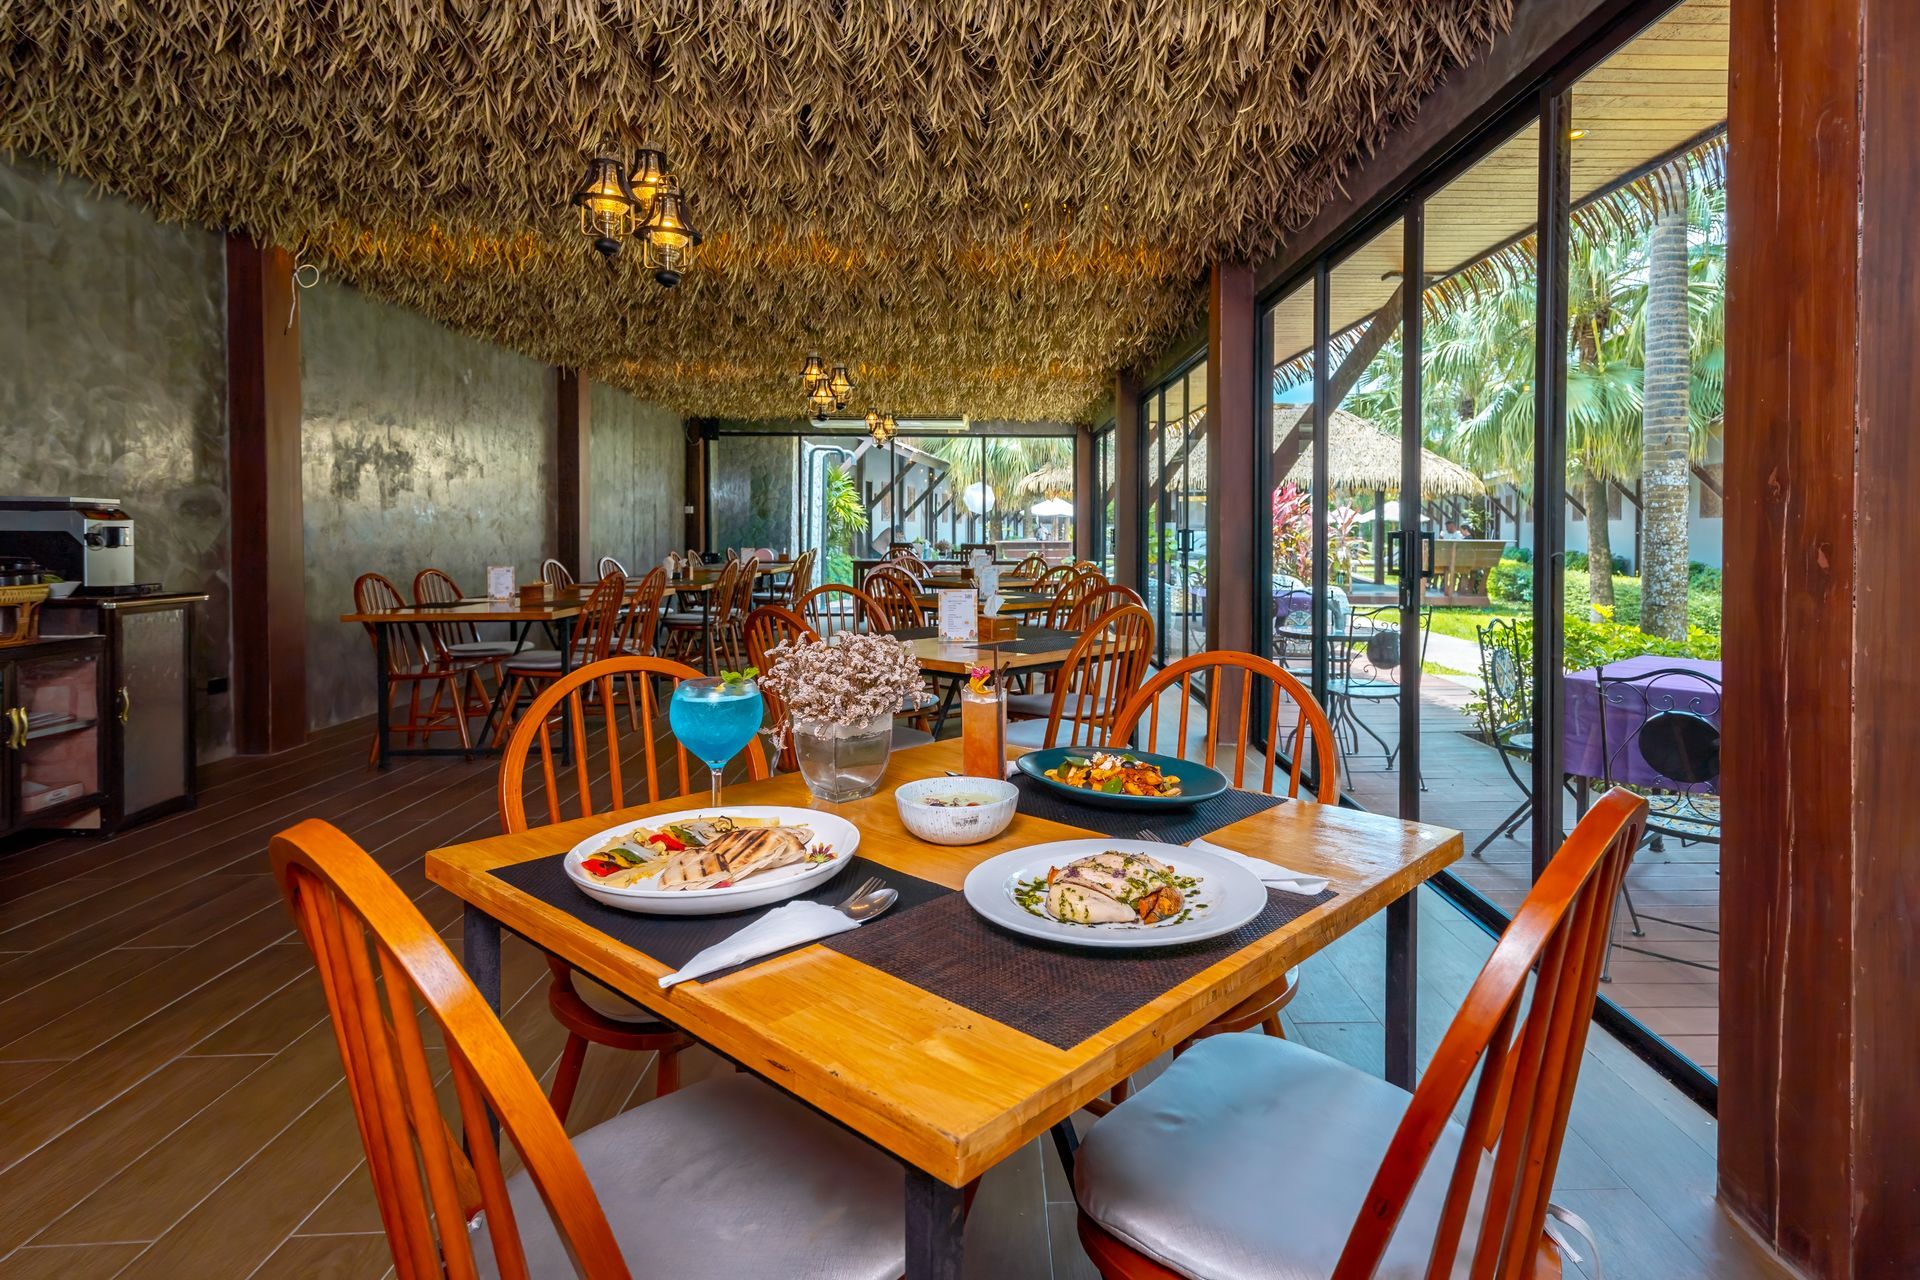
[584,382,687,578]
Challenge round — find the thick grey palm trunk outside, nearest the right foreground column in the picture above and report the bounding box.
[1640,180,1692,639]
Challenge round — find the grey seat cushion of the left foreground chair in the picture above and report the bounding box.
[472,1075,906,1280]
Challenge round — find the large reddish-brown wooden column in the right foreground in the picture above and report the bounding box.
[1718,0,1920,1280]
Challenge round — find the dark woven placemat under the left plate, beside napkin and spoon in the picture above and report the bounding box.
[493,854,952,983]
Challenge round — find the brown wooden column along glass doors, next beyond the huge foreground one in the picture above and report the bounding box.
[1206,263,1260,652]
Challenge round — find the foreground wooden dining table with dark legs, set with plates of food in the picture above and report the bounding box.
[426,741,1461,1280]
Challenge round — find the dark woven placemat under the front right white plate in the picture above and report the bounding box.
[822,889,1338,1050]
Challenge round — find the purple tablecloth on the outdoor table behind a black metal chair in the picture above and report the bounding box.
[1561,654,1720,791]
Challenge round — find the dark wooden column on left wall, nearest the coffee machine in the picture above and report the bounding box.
[227,236,307,756]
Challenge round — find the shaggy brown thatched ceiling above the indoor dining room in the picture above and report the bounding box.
[0,0,1511,418]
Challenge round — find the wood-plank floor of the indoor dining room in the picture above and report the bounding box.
[0,725,1774,1280]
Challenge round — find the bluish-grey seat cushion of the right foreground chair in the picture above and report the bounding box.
[1073,1034,1492,1280]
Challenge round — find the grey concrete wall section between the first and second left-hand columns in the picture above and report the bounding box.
[300,282,555,727]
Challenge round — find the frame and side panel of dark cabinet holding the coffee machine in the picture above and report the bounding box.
[23,595,207,831]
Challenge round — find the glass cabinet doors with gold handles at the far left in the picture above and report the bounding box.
[0,635,111,833]
